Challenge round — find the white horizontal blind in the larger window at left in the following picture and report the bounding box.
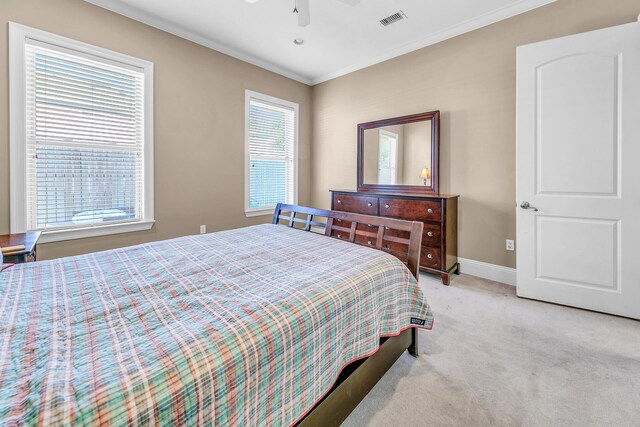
[25,41,144,230]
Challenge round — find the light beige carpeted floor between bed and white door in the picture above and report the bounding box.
[343,274,640,427]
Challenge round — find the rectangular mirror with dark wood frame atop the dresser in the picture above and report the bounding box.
[358,111,440,194]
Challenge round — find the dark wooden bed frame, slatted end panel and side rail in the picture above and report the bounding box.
[273,203,423,427]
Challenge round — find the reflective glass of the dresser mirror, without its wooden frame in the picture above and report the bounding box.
[362,120,433,187]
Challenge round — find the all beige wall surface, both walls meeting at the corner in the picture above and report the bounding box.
[0,0,640,267]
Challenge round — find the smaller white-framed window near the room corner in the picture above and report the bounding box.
[244,91,298,216]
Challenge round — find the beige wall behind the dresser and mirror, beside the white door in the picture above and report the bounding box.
[311,0,640,267]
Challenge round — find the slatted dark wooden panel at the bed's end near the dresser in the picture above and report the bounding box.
[273,203,424,279]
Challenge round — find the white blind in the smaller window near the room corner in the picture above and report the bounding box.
[248,98,296,209]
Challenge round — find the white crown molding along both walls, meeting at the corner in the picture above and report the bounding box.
[85,0,556,86]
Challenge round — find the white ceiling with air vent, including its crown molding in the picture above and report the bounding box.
[86,0,555,84]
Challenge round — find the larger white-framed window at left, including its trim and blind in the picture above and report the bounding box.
[10,23,153,242]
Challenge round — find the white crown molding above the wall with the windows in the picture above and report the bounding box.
[84,0,312,85]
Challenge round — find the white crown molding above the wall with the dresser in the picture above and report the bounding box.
[311,0,556,85]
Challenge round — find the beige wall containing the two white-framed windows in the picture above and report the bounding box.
[0,0,311,259]
